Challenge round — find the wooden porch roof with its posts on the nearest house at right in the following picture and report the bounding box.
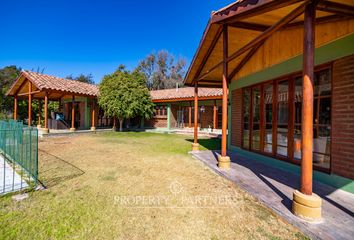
[185,0,354,221]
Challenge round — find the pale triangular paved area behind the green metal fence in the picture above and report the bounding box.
[0,154,28,195]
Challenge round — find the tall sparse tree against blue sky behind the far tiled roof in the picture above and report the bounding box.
[135,50,186,90]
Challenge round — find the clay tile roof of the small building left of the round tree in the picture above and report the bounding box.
[22,71,99,96]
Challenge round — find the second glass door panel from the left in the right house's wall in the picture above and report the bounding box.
[251,87,261,151]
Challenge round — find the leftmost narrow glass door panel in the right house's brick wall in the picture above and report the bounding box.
[242,88,251,149]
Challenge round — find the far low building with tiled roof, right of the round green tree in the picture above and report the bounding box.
[148,87,222,132]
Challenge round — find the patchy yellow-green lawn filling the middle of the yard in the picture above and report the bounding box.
[0,133,306,240]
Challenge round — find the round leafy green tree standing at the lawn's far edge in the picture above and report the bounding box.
[98,65,154,131]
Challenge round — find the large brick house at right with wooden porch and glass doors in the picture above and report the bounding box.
[185,0,354,219]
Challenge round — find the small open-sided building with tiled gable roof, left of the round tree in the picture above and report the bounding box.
[7,71,113,132]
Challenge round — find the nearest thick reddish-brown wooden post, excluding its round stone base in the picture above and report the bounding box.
[300,4,316,195]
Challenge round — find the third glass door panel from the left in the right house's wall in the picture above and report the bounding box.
[262,84,273,153]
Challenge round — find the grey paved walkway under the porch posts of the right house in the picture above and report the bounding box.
[191,151,354,240]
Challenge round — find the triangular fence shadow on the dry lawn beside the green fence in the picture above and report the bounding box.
[38,149,85,188]
